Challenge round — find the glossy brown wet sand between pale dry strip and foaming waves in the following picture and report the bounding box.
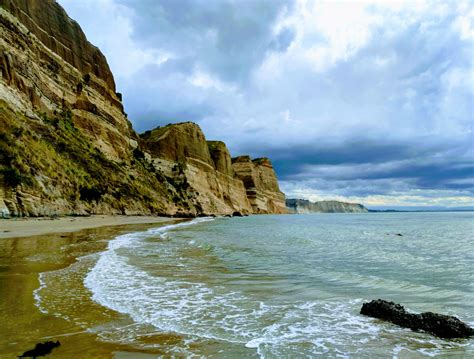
[0,223,178,358]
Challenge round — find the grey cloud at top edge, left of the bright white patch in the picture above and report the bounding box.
[117,0,294,81]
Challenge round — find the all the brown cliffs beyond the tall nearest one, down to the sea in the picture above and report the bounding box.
[142,122,285,214]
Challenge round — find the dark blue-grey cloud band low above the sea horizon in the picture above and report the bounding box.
[256,139,474,196]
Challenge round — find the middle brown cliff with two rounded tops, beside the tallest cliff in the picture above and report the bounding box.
[142,122,253,214]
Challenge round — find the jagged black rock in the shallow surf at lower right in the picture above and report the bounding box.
[360,299,474,338]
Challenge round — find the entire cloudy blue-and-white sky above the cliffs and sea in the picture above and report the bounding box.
[58,0,474,208]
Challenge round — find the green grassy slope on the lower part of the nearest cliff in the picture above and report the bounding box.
[0,101,180,214]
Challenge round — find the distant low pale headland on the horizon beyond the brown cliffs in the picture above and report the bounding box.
[286,199,368,213]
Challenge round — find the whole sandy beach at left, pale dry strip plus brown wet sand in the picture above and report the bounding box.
[0,221,187,358]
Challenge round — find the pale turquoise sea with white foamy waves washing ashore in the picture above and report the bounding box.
[44,212,474,358]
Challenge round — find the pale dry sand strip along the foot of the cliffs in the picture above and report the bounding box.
[0,215,183,239]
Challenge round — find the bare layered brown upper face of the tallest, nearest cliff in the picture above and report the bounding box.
[0,0,133,160]
